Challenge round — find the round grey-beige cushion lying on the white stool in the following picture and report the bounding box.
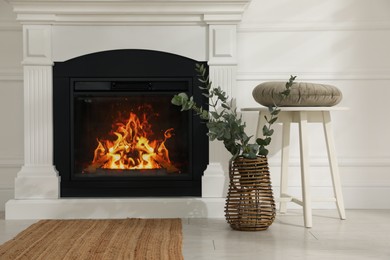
[252,81,342,107]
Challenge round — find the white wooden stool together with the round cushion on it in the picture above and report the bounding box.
[242,82,346,227]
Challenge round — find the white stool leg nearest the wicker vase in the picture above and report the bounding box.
[279,116,291,213]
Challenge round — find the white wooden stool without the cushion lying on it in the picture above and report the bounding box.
[241,107,348,228]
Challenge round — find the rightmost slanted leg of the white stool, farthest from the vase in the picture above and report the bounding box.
[322,111,346,219]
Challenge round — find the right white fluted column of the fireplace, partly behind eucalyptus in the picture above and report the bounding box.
[202,19,241,198]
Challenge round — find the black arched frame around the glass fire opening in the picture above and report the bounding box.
[53,49,209,197]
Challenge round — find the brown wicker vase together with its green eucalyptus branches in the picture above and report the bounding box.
[172,65,295,231]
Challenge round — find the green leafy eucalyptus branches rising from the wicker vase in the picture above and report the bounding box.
[172,64,295,159]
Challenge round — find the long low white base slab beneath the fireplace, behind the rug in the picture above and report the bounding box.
[5,198,225,219]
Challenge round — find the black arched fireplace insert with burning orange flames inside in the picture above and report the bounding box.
[53,50,208,197]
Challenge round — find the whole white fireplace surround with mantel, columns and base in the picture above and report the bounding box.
[6,0,250,219]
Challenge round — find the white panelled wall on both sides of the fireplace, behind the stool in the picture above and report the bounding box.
[0,0,390,210]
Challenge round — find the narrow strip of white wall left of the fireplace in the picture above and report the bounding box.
[0,0,23,210]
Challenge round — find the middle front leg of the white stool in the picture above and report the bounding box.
[298,111,313,227]
